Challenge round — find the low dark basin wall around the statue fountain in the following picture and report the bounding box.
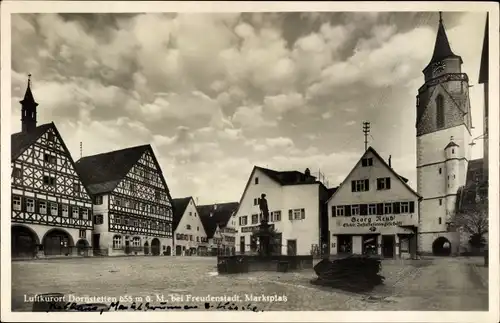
[217,255,313,274]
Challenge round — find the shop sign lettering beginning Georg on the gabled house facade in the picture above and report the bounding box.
[336,214,417,233]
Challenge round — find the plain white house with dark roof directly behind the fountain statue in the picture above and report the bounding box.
[236,167,326,255]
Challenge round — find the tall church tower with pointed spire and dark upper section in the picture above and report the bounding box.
[416,13,472,255]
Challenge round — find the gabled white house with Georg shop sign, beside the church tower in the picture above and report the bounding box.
[328,147,419,258]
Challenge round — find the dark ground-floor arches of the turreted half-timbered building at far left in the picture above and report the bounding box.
[11,225,90,258]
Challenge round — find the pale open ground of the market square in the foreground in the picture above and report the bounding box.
[12,257,488,311]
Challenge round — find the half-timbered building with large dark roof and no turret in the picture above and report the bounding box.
[76,144,173,256]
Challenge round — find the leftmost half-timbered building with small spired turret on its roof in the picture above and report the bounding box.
[11,81,93,258]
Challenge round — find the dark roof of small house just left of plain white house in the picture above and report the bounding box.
[196,202,239,239]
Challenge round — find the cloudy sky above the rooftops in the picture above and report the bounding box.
[12,12,486,204]
